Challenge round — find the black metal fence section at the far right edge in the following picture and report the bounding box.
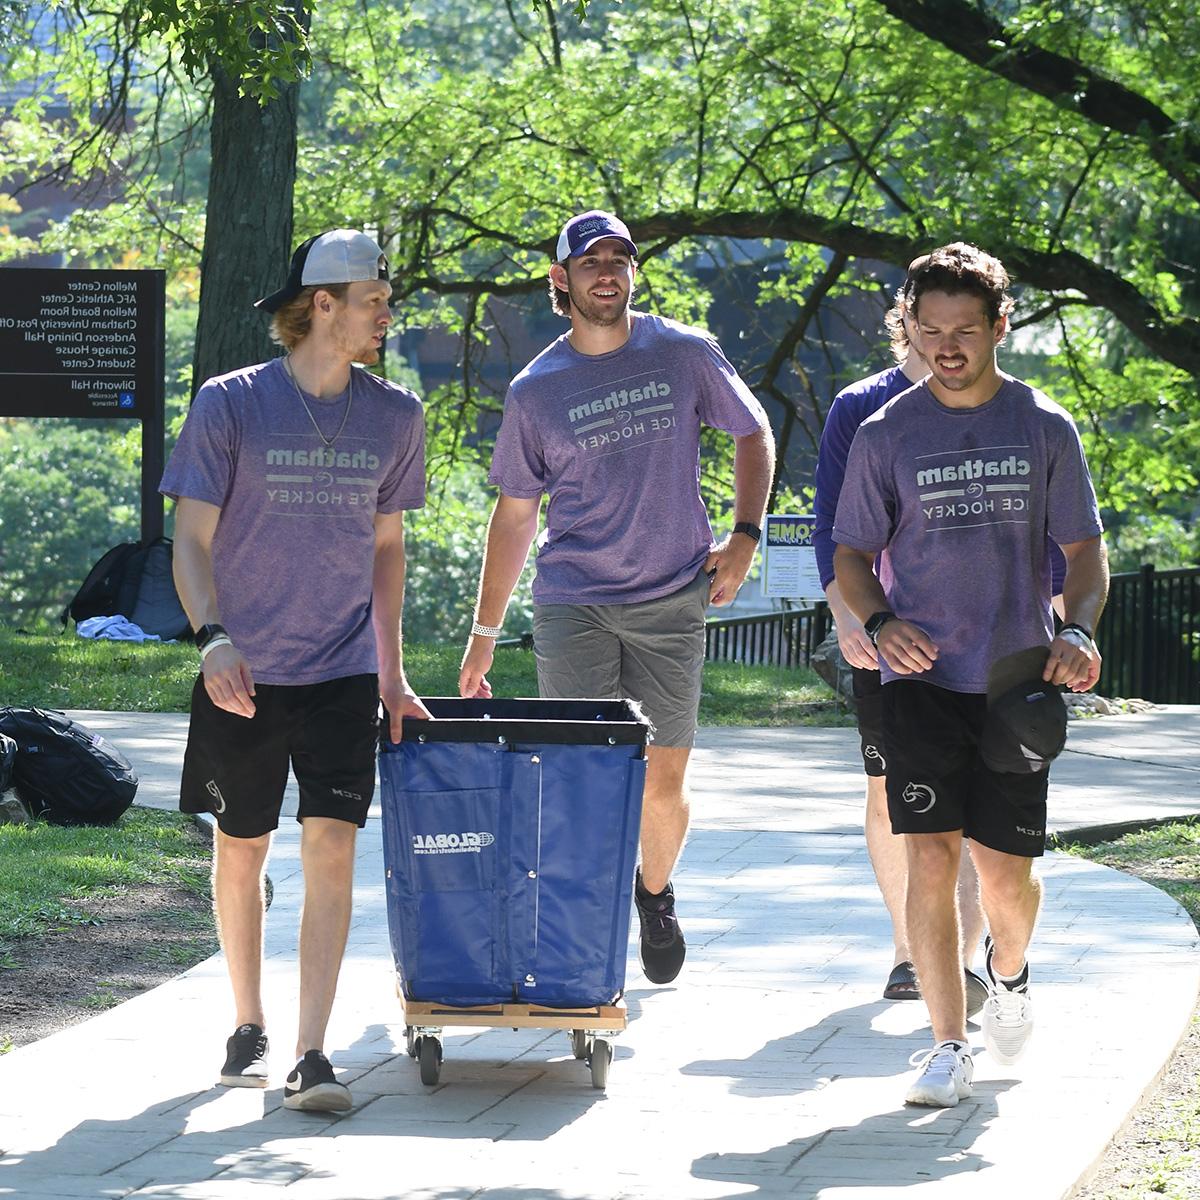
[1096,565,1200,704]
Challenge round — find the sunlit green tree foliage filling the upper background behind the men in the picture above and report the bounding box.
[0,0,1200,637]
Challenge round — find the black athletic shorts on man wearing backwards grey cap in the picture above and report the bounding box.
[179,674,379,838]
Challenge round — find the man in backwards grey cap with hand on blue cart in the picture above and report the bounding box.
[161,229,428,1112]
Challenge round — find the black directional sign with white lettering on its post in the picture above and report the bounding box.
[0,268,167,541]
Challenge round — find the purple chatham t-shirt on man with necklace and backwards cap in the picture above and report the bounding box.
[160,359,425,685]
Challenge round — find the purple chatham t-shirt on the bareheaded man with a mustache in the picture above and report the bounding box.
[833,376,1103,692]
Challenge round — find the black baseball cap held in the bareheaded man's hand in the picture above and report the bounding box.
[979,646,1067,775]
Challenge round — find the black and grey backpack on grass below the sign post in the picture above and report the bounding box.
[60,538,191,641]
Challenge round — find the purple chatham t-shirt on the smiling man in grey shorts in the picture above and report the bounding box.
[488,313,767,604]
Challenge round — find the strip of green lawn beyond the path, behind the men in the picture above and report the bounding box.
[0,629,853,725]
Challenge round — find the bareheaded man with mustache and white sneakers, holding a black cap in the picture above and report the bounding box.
[833,242,1108,1108]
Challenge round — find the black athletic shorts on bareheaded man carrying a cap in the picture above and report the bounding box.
[883,679,1050,858]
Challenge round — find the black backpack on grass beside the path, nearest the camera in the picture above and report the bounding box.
[0,707,138,826]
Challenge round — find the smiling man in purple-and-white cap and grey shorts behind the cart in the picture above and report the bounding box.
[458,211,774,984]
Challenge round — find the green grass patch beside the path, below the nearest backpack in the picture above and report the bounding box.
[0,806,209,949]
